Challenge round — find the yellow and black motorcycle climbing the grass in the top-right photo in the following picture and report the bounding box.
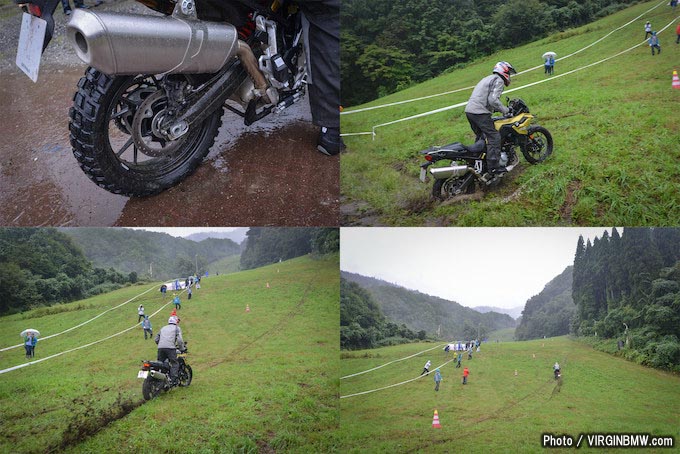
[420,99,553,200]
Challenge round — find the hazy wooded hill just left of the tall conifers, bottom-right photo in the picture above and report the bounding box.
[515,266,576,340]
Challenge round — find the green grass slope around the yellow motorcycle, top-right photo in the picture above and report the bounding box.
[341,1,680,226]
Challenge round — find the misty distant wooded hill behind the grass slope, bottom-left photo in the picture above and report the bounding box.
[60,227,241,279]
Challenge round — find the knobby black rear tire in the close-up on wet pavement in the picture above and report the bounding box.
[69,68,223,197]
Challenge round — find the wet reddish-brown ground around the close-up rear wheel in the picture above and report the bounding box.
[0,0,340,226]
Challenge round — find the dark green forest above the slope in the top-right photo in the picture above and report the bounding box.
[340,0,637,106]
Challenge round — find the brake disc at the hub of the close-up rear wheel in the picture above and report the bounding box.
[132,90,187,158]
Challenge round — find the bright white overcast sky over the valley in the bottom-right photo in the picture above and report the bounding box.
[340,227,621,308]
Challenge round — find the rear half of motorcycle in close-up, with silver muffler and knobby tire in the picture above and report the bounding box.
[14,0,307,196]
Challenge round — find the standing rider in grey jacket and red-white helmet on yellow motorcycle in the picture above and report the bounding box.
[465,61,517,175]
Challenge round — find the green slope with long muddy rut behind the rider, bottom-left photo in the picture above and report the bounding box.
[0,257,339,452]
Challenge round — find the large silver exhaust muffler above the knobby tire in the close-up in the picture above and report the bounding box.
[66,8,238,75]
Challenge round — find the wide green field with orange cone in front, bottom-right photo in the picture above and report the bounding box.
[340,337,680,452]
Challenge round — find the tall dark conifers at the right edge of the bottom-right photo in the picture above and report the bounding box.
[573,227,680,372]
